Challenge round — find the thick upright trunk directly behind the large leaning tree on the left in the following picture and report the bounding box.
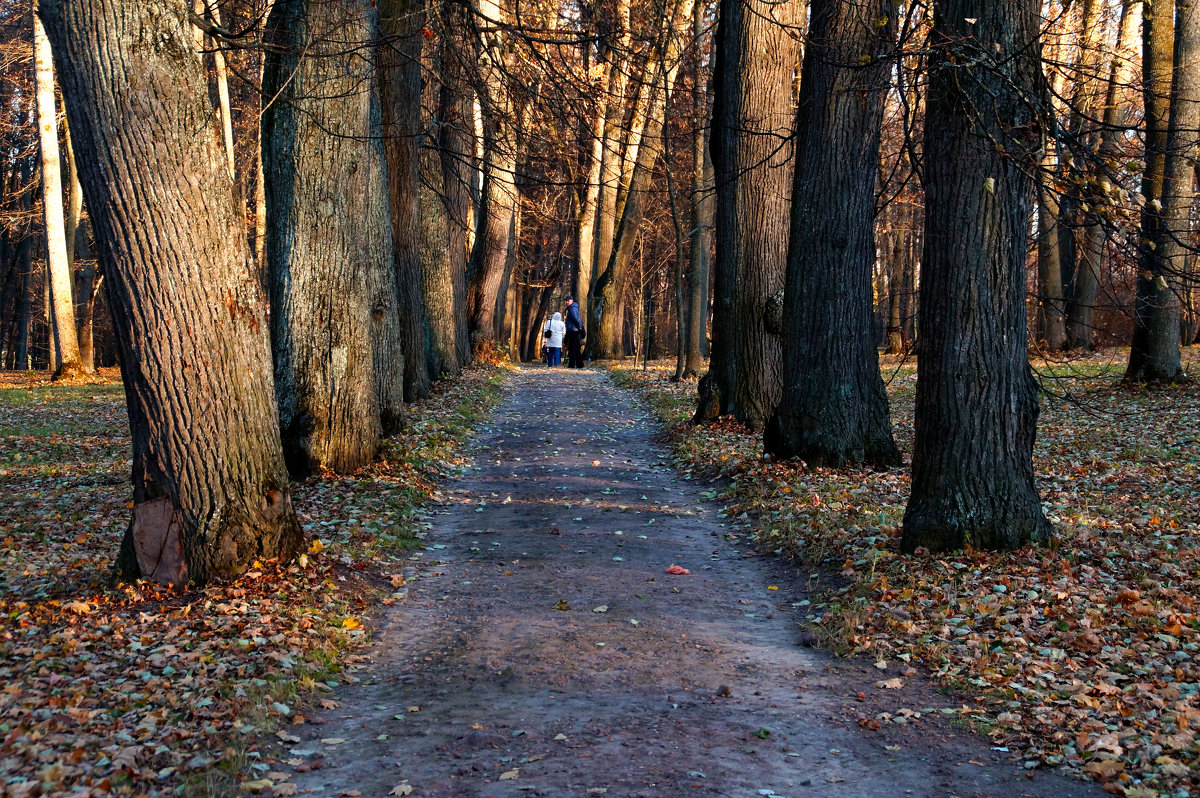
[263,0,403,475]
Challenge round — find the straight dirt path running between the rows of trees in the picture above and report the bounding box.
[280,368,1100,798]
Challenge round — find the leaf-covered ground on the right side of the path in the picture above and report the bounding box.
[616,347,1200,798]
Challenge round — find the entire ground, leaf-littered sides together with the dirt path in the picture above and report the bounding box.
[0,353,1200,798]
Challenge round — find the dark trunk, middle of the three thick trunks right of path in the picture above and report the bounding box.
[763,0,900,468]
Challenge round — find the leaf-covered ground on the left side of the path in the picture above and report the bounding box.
[0,367,505,797]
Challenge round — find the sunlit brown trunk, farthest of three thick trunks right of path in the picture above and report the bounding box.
[697,0,804,430]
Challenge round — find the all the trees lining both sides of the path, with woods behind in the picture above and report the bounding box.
[0,0,1200,583]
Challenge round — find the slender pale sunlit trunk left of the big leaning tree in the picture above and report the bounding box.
[34,8,86,379]
